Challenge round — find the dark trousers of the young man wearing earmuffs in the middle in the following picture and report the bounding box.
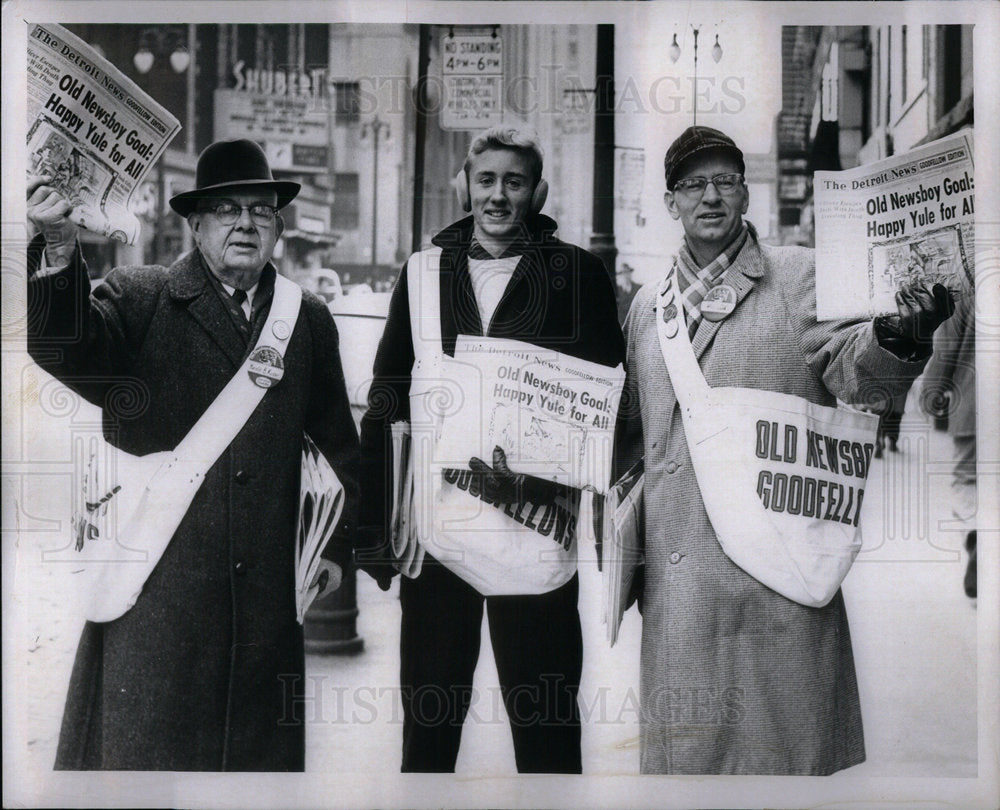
[400,556,583,773]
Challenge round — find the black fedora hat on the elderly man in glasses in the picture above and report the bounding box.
[170,138,302,217]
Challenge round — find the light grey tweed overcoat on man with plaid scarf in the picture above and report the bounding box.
[616,238,924,775]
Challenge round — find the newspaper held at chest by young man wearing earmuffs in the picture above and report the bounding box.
[434,335,625,493]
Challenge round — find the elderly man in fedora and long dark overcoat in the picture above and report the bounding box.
[28,140,357,771]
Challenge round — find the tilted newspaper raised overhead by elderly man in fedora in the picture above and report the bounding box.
[28,23,181,245]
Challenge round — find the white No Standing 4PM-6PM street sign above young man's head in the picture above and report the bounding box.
[441,34,503,130]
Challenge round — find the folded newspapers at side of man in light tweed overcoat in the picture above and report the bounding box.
[601,461,644,646]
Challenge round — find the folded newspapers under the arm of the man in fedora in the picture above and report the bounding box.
[295,434,344,624]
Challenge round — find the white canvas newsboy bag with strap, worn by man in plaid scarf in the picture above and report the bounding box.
[656,268,878,607]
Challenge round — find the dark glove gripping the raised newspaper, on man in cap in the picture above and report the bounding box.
[875,282,955,362]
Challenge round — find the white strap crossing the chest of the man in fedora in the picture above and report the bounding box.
[157,276,302,474]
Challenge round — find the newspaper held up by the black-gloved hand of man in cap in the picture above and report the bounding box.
[813,130,976,321]
